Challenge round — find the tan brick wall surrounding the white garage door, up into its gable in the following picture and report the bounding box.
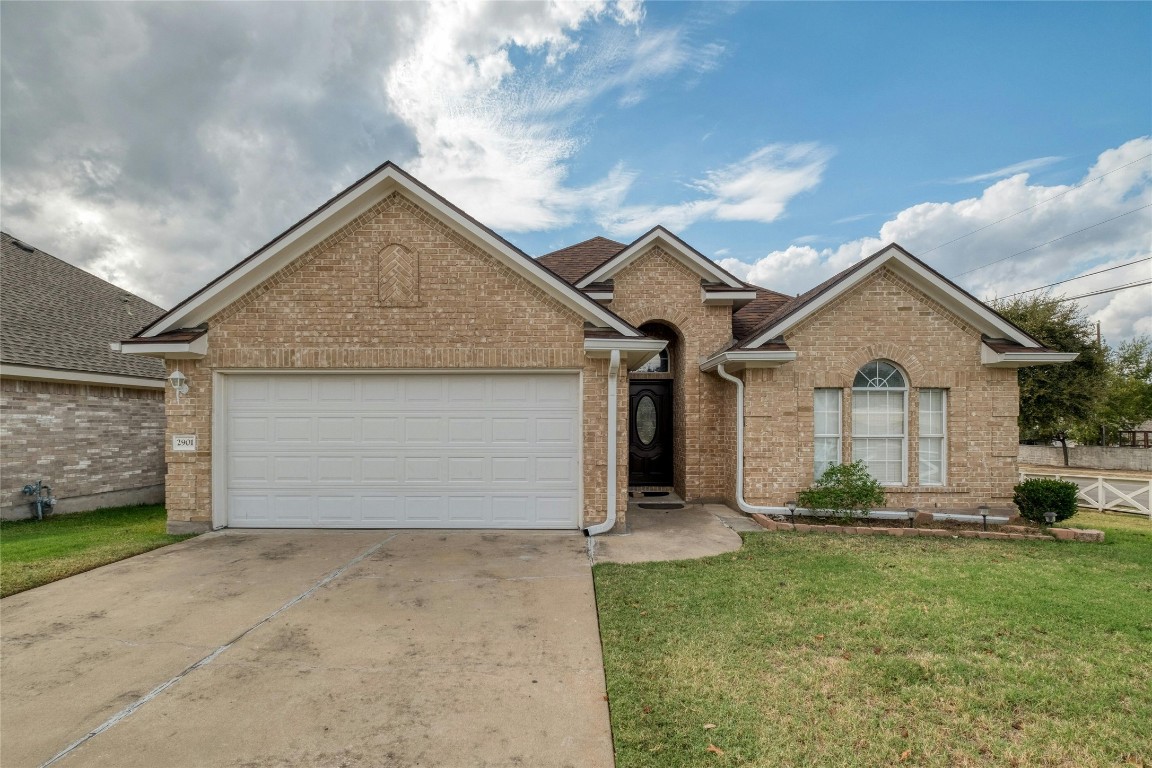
[167,188,627,531]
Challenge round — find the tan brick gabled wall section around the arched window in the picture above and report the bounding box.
[744,269,1018,509]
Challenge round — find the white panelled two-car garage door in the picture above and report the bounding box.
[223,373,581,529]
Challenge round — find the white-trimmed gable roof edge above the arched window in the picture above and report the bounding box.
[737,243,1043,349]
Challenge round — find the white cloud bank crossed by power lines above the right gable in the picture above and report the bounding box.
[720,137,1152,340]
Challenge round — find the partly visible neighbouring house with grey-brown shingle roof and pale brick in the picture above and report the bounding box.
[0,234,165,519]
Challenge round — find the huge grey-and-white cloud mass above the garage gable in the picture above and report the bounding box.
[0,0,722,306]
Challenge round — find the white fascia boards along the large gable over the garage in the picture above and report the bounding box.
[141,166,637,336]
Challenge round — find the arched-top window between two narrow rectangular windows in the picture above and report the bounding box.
[852,360,908,485]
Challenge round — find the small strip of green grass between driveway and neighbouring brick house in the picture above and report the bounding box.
[0,507,189,598]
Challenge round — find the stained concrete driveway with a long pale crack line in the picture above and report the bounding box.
[0,531,613,768]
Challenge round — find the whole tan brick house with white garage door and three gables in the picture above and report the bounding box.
[123,162,1070,533]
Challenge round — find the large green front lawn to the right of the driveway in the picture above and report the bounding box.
[594,512,1152,768]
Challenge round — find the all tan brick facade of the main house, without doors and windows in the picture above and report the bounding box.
[155,179,1017,530]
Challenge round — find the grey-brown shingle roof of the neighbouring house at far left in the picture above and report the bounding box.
[0,233,165,379]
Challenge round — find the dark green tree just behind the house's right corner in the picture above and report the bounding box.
[993,294,1108,466]
